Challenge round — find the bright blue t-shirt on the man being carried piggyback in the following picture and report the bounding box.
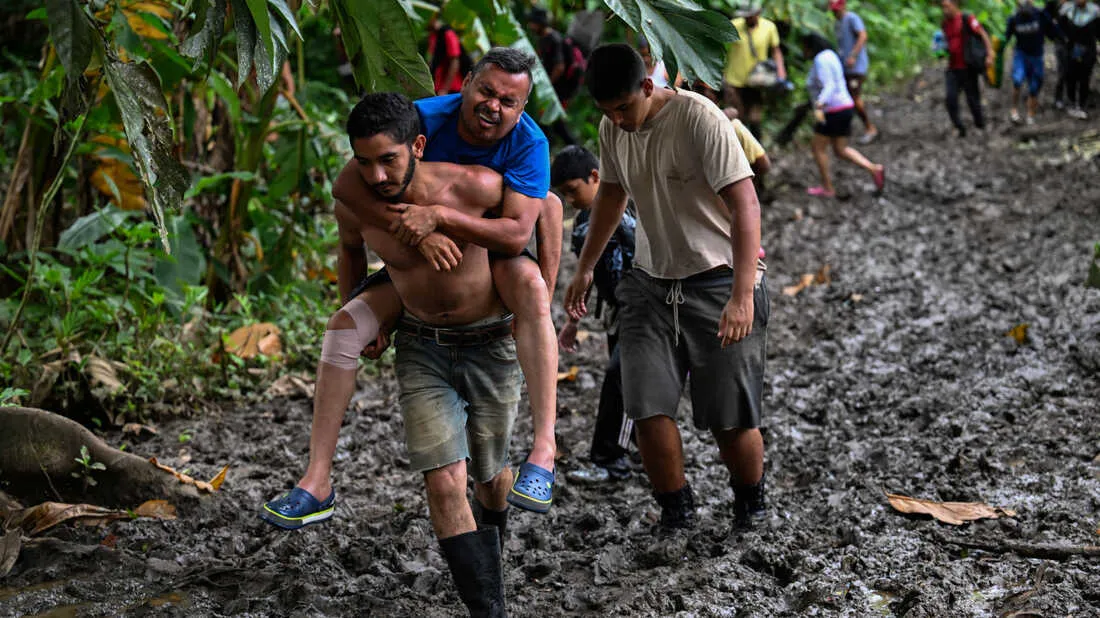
[416,93,550,199]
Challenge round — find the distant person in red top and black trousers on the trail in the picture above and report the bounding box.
[943,0,994,137]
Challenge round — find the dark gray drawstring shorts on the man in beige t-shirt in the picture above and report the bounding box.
[615,265,771,431]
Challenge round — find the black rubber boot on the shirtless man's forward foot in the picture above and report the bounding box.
[439,528,508,618]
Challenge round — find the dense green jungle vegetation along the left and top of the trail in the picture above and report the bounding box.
[0,0,1073,423]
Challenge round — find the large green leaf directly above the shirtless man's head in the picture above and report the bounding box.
[330,0,435,99]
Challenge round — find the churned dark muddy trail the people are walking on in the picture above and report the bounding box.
[0,73,1100,617]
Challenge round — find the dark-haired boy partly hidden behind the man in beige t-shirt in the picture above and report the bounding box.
[550,146,635,483]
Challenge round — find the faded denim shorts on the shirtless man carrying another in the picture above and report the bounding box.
[394,316,523,483]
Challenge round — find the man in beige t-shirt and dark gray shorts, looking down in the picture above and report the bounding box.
[565,44,770,530]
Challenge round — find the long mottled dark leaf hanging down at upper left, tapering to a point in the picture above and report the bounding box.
[103,59,190,251]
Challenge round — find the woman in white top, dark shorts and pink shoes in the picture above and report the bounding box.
[802,33,887,198]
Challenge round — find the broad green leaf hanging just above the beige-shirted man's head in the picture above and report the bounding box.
[605,0,737,84]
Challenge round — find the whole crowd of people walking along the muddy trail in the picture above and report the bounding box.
[261,0,1100,617]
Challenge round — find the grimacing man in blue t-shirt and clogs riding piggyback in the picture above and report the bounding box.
[265,48,561,528]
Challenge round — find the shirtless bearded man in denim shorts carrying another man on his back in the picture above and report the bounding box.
[268,92,512,616]
